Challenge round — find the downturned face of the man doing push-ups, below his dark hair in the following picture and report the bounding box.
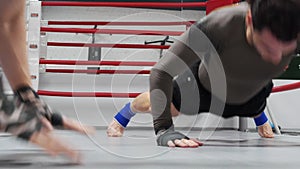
[252,28,297,65]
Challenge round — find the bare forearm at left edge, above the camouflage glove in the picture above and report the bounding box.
[0,0,31,91]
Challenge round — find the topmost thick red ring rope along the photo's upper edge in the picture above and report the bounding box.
[42,1,206,8]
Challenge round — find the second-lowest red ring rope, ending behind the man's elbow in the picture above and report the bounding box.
[45,69,150,74]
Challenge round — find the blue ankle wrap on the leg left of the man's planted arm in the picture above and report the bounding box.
[114,103,135,128]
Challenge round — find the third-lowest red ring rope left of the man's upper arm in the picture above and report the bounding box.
[40,59,156,66]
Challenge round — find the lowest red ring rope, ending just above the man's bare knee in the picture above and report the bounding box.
[38,90,140,98]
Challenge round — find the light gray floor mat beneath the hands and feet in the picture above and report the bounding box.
[0,130,300,169]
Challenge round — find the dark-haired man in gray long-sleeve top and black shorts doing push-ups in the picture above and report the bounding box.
[106,0,300,147]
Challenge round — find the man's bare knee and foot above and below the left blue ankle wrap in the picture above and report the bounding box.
[106,92,180,137]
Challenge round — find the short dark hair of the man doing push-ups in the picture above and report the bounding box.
[247,0,300,41]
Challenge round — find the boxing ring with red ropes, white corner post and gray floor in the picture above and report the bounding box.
[0,0,300,169]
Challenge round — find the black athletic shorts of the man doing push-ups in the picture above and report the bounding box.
[172,62,273,118]
